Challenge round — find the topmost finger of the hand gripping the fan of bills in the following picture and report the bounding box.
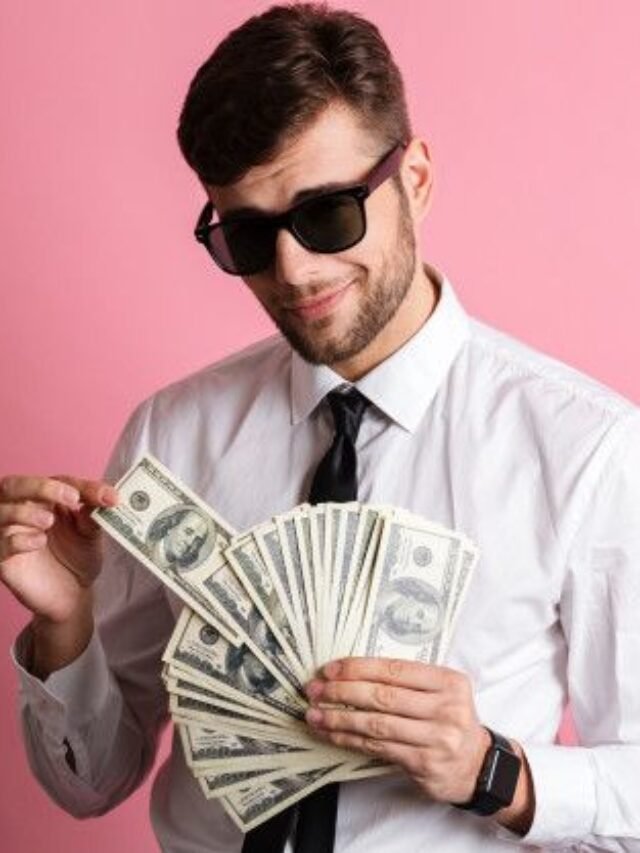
[322,658,456,691]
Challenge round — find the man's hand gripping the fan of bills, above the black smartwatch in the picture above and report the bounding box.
[307,658,533,833]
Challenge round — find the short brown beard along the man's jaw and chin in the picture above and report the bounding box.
[265,186,416,365]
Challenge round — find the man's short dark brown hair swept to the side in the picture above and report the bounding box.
[178,3,411,186]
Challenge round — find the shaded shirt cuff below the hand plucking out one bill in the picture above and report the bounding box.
[11,627,111,736]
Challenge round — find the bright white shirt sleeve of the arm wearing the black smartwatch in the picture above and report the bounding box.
[522,412,640,851]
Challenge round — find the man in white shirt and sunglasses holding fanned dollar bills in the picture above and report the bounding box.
[0,6,640,853]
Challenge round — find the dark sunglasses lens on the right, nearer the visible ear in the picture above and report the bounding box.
[293,193,366,252]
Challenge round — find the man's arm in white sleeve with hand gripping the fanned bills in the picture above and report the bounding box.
[307,417,640,851]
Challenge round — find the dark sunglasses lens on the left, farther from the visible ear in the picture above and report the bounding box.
[209,219,275,275]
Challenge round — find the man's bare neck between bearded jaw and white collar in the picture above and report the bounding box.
[331,263,438,382]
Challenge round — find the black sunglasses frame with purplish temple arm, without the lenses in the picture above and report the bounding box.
[193,142,407,276]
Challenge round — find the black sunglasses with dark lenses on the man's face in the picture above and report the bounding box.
[194,143,406,276]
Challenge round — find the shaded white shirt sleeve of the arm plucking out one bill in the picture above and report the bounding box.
[13,396,174,817]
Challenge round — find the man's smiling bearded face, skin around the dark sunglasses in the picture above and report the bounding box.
[209,105,417,365]
